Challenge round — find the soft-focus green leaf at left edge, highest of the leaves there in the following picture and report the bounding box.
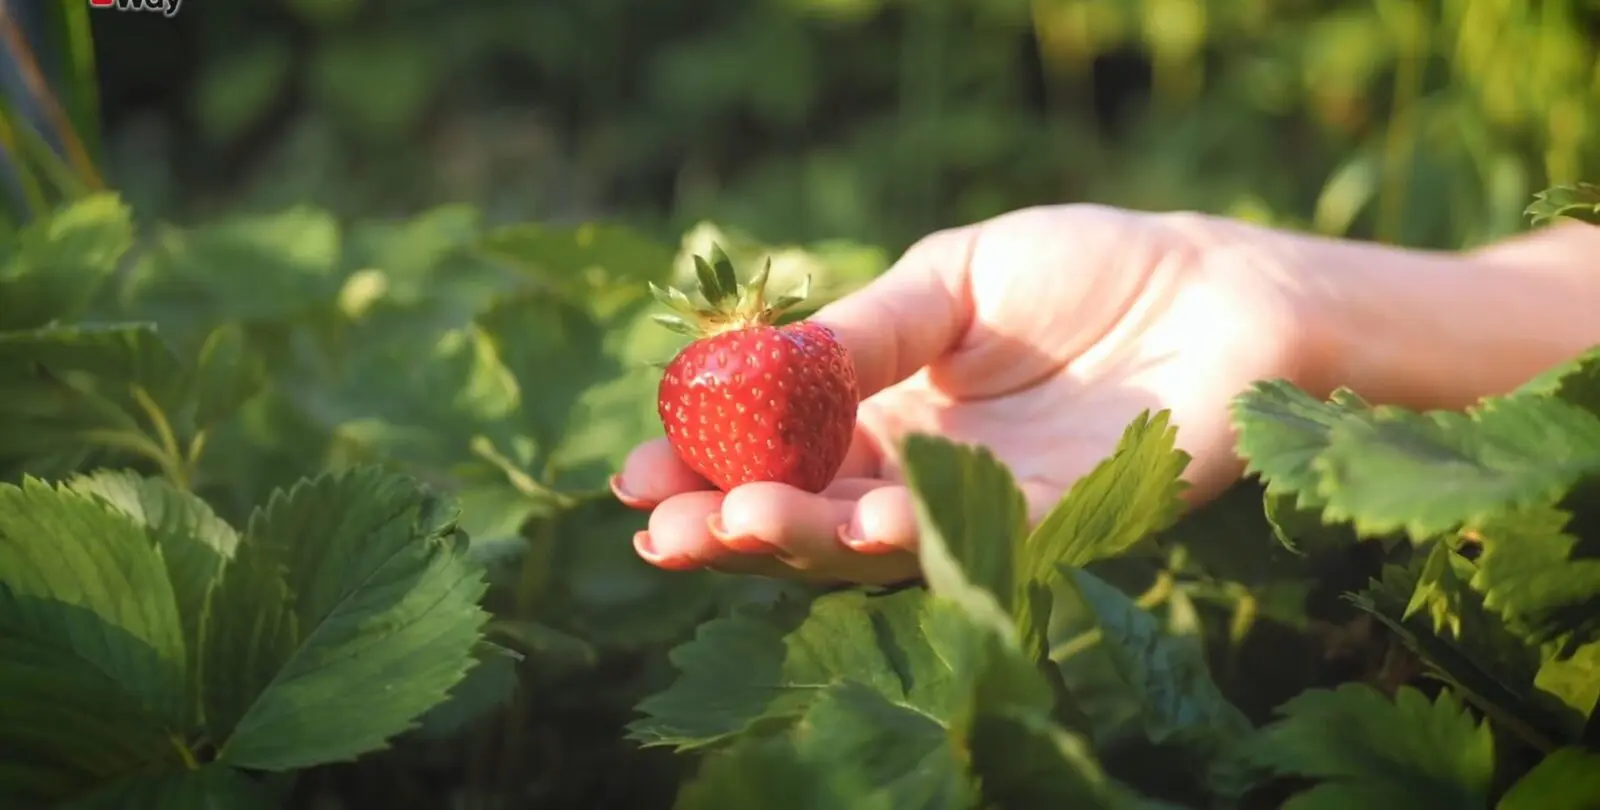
[0,194,133,330]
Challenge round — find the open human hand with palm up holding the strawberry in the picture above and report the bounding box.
[613,205,1324,583]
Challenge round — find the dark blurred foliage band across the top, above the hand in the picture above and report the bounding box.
[13,0,1600,251]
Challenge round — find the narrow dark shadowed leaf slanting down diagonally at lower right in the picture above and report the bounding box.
[1350,560,1587,746]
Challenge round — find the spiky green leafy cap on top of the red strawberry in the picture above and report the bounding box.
[650,245,811,338]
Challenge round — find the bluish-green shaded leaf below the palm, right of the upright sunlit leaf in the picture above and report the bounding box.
[1048,568,1251,756]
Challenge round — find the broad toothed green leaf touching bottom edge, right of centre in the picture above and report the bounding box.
[1248,684,1494,810]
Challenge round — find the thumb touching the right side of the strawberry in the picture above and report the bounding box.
[810,226,978,399]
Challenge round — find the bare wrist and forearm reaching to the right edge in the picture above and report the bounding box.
[1286,224,1600,410]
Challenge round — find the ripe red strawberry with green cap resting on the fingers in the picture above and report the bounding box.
[650,247,858,491]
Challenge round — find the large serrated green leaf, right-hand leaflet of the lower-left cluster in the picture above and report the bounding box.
[206,467,486,770]
